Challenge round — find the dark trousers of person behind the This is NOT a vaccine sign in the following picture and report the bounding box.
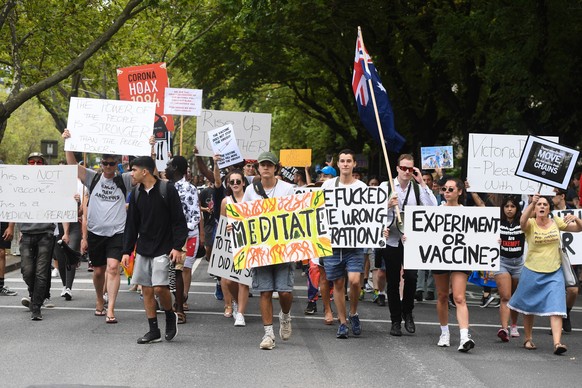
[20,233,55,308]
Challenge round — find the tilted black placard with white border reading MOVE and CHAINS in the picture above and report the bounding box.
[515,136,580,190]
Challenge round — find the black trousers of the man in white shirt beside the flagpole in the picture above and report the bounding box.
[377,241,417,322]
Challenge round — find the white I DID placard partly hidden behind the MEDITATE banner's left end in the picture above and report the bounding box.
[208,216,253,287]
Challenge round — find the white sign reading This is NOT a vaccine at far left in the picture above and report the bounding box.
[0,164,78,223]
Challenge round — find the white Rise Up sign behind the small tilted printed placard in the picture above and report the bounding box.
[196,110,271,159]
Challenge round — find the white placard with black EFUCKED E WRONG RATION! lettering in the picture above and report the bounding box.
[324,187,388,248]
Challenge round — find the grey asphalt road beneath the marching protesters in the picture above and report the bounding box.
[0,262,582,387]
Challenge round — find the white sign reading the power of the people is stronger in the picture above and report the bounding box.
[65,97,156,156]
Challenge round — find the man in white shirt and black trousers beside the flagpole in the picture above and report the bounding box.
[376,154,437,337]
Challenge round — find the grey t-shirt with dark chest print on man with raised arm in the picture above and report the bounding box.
[84,170,131,237]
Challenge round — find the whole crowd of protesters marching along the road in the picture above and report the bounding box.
[0,139,582,354]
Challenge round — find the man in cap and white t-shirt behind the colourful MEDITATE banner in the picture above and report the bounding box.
[243,152,295,350]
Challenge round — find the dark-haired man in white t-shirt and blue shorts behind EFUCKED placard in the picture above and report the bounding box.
[321,149,367,339]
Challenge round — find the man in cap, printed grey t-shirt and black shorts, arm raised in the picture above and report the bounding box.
[63,130,131,323]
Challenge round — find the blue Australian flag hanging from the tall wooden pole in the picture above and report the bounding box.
[352,29,406,152]
